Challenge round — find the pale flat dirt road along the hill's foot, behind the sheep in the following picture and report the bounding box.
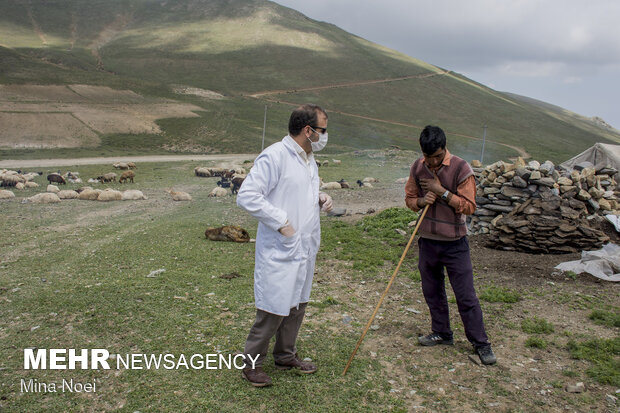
[0,153,258,168]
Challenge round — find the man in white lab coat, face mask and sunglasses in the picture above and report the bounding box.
[237,105,332,387]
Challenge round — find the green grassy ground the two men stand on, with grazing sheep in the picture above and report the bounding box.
[0,151,620,412]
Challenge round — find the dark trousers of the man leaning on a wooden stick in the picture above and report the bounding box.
[418,237,489,348]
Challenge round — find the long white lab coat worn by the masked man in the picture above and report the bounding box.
[237,137,321,316]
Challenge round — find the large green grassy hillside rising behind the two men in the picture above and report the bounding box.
[0,0,620,161]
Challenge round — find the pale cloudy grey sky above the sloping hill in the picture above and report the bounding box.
[276,0,620,130]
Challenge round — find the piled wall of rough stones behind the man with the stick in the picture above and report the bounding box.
[470,158,620,253]
